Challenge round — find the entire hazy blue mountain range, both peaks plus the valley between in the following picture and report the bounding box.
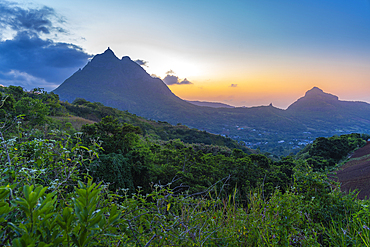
[54,48,370,147]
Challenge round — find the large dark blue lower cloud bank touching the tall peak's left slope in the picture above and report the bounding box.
[0,32,90,90]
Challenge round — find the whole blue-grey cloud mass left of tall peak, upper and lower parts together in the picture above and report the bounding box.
[0,2,91,90]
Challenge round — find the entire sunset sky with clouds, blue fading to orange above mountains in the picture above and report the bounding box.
[0,0,370,109]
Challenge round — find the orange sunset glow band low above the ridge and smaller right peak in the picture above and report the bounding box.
[170,63,369,109]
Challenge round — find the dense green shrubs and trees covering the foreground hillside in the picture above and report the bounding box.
[0,86,370,246]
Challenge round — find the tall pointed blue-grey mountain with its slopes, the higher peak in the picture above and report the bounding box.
[54,48,202,119]
